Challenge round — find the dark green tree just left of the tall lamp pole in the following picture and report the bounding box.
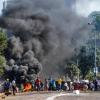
[78,46,94,79]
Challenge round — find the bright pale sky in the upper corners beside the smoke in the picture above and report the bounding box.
[0,0,100,17]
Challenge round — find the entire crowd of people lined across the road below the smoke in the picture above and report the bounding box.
[1,77,98,95]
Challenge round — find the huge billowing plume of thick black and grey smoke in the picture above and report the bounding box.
[0,0,89,79]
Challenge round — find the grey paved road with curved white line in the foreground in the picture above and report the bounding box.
[2,93,100,100]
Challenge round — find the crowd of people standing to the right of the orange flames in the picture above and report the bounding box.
[34,78,100,91]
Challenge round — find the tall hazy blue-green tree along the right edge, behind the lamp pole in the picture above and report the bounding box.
[89,11,100,77]
